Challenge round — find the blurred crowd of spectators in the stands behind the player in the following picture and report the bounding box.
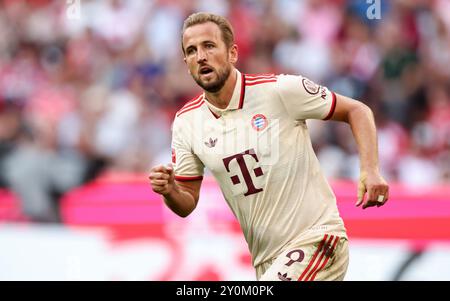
[0,0,450,222]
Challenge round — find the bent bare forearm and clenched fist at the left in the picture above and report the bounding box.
[149,165,202,217]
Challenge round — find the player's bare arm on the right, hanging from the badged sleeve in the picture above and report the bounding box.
[331,94,389,209]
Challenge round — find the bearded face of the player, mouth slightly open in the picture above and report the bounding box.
[183,22,237,93]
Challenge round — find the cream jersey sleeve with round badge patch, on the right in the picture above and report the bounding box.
[277,74,336,120]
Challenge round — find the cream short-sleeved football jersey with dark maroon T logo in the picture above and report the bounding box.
[172,70,346,266]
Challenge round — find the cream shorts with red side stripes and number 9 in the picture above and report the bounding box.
[256,234,348,281]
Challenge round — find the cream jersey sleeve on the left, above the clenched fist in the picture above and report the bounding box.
[172,117,204,181]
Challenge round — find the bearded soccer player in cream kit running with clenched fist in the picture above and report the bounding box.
[149,13,389,281]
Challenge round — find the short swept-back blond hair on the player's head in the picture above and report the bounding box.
[181,12,234,53]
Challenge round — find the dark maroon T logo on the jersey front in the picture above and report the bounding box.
[223,149,263,196]
